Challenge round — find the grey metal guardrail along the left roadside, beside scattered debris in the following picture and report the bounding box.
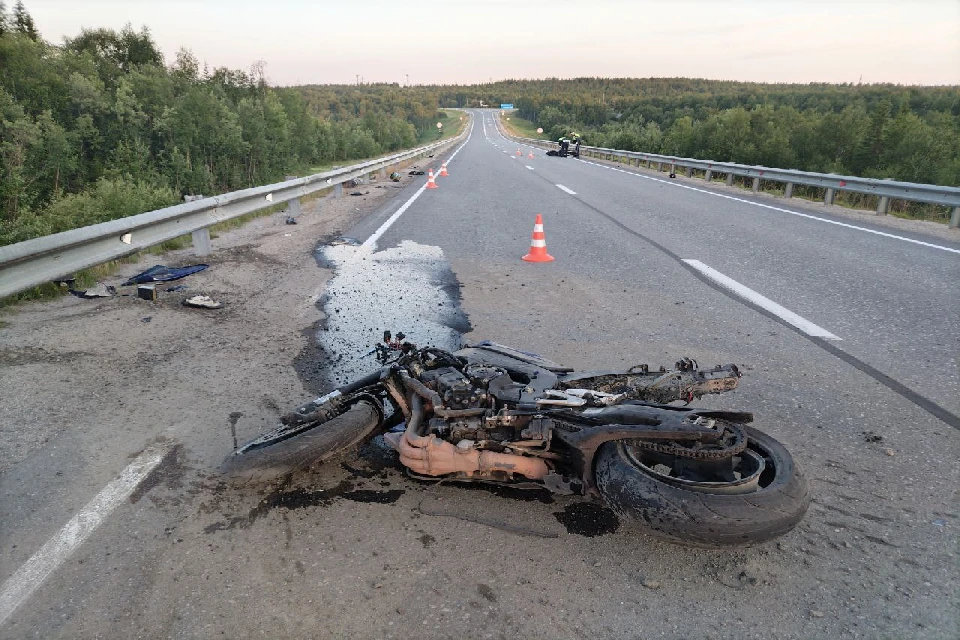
[0,126,469,298]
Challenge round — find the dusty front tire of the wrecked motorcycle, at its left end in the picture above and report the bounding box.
[220,401,382,482]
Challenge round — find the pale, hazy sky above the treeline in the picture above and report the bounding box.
[20,0,960,85]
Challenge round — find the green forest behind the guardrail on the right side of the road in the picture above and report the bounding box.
[430,78,960,186]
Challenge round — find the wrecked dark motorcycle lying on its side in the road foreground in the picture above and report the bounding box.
[224,337,810,547]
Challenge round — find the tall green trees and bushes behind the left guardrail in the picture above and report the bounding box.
[0,0,438,245]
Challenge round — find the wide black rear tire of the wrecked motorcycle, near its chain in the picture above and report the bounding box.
[594,427,810,549]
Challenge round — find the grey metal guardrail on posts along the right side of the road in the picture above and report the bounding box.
[503,126,960,228]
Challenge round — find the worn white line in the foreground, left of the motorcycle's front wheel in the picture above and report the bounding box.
[0,444,170,626]
